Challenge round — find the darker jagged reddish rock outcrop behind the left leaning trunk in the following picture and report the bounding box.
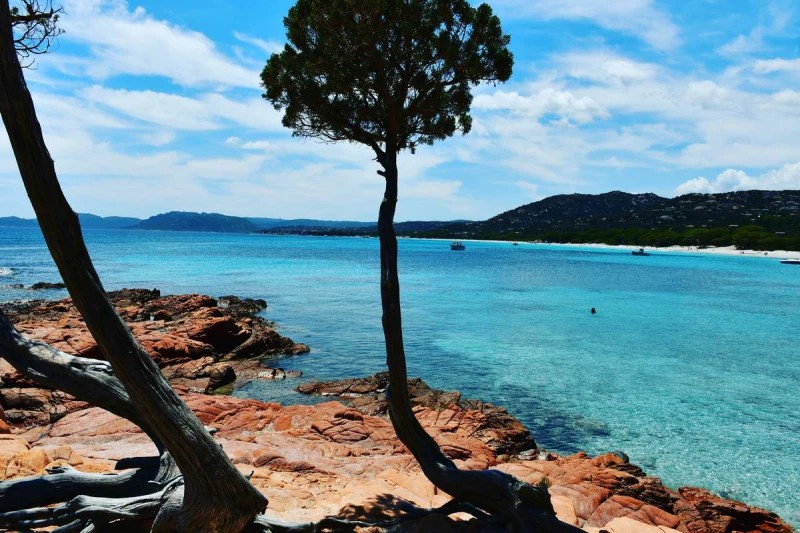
[0,289,308,426]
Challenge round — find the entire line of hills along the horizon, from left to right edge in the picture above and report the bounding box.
[0,190,800,250]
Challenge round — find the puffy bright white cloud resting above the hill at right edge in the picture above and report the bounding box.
[675,162,800,195]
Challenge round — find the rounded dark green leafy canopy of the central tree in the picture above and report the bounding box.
[261,0,513,153]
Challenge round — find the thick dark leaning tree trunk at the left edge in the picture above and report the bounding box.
[0,0,267,531]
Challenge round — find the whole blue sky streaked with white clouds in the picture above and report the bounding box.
[0,0,800,221]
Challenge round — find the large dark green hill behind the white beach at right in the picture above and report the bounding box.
[418,191,800,250]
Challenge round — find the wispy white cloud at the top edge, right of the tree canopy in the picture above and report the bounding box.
[492,0,680,50]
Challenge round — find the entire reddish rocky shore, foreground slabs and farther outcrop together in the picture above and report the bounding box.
[0,290,792,533]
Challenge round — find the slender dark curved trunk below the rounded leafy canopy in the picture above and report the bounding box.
[376,152,581,533]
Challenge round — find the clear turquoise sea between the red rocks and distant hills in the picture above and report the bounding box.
[0,228,800,526]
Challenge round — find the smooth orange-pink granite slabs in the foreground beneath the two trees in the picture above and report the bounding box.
[0,389,791,533]
